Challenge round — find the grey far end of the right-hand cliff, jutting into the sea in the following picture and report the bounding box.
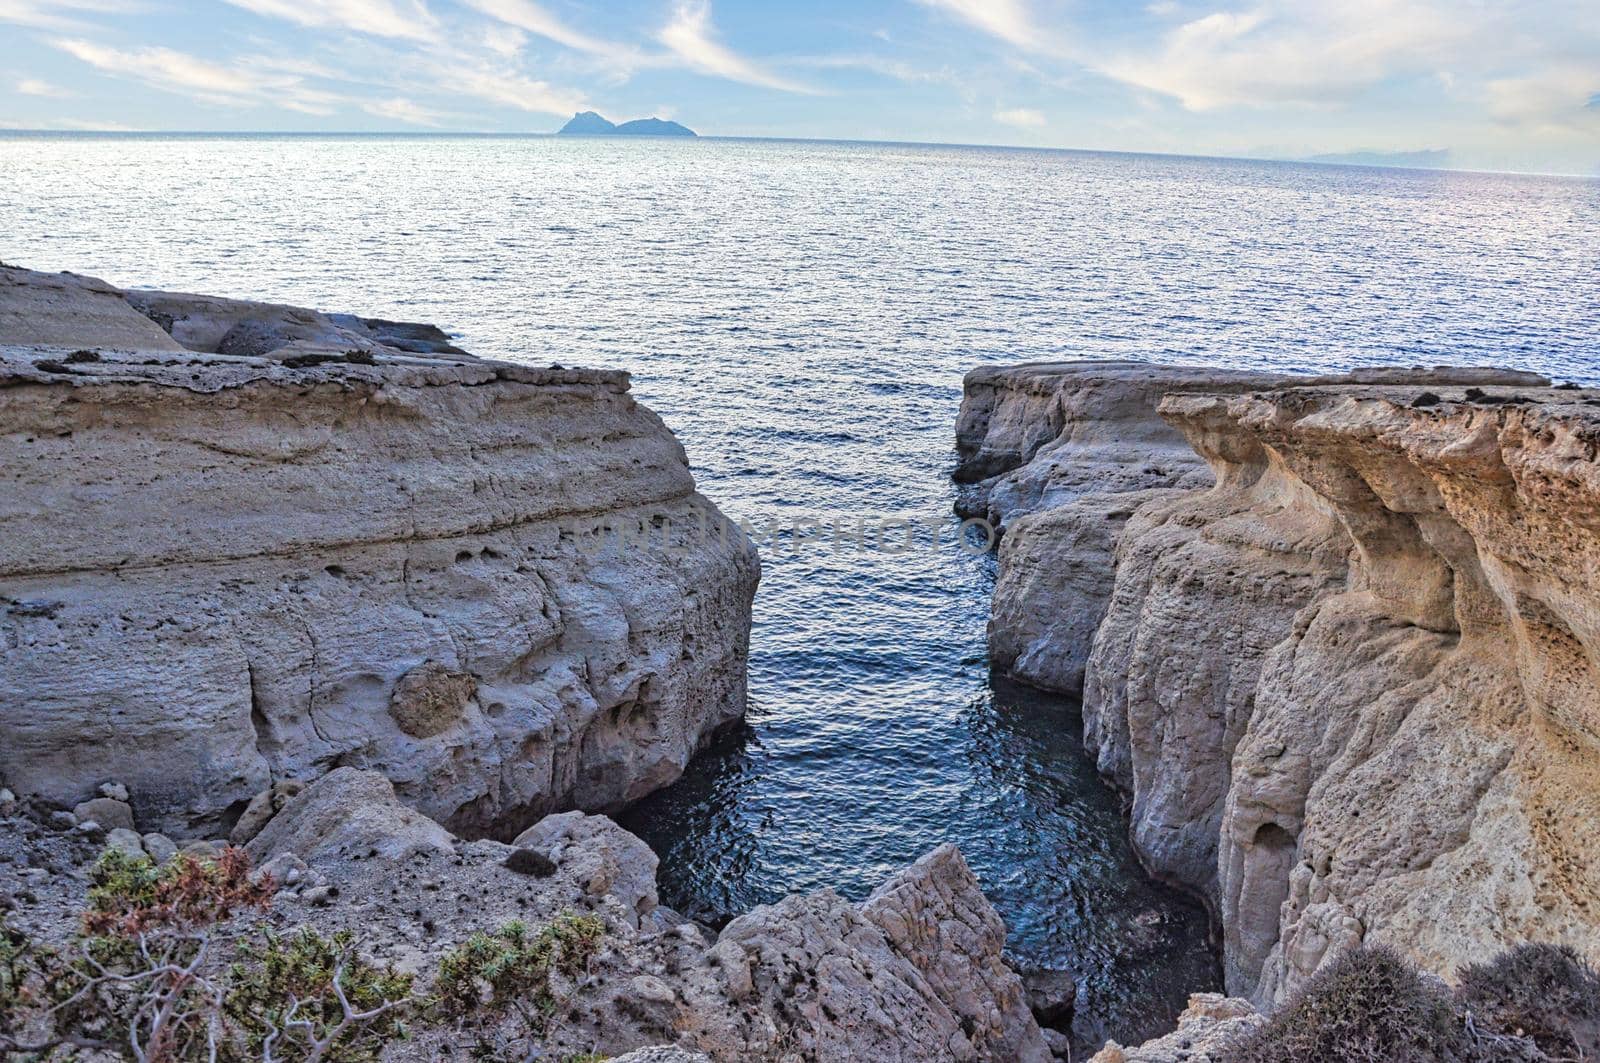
[954,362,1547,693]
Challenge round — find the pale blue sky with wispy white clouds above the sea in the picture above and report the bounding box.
[0,0,1600,173]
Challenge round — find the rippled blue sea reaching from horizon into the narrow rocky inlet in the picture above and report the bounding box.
[0,136,1600,1039]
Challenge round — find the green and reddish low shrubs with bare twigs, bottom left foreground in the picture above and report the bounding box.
[0,848,605,1063]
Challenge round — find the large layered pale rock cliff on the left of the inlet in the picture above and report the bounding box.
[0,269,758,837]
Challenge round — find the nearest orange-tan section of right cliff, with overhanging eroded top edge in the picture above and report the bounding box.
[1203,389,1600,1002]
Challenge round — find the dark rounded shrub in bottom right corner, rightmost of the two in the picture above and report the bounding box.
[1456,945,1600,1060]
